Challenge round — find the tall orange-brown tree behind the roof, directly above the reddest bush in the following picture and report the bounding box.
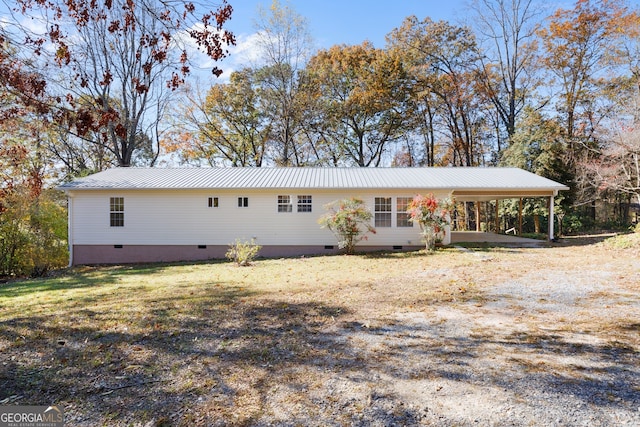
[387,16,486,166]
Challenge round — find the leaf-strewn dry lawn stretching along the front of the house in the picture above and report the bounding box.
[0,244,638,426]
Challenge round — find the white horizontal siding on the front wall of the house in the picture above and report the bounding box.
[71,189,446,246]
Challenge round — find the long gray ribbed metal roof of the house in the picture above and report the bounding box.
[58,168,568,191]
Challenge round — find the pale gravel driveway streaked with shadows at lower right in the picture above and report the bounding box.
[260,244,640,427]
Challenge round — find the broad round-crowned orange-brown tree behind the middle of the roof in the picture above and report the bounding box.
[306,42,408,166]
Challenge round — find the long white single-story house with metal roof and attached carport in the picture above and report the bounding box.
[59,168,568,265]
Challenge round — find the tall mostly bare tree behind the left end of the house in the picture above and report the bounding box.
[7,0,234,166]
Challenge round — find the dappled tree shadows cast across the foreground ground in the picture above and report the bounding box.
[0,280,640,426]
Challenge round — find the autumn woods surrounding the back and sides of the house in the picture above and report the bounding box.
[0,0,640,275]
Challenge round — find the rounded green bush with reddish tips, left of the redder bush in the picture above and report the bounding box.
[318,198,376,255]
